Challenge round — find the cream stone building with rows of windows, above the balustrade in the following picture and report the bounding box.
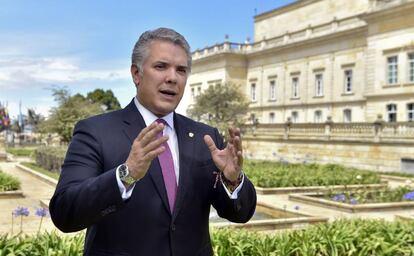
[183,0,414,123]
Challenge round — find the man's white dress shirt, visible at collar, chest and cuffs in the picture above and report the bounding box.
[116,97,244,200]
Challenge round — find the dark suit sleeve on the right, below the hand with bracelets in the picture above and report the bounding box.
[212,129,256,223]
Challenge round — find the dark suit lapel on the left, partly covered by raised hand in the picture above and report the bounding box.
[123,100,170,215]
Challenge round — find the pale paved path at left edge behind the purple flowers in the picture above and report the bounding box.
[0,162,56,234]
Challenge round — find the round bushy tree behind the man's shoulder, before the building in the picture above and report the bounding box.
[188,83,249,133]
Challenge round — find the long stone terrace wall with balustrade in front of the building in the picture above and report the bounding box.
[243,123,414,173]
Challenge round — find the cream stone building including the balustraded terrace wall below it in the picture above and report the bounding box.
[183,0,414,172]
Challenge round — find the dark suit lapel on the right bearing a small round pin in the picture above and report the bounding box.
[173,114,194,221]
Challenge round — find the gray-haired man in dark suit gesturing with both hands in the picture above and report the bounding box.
[50,28,256,256]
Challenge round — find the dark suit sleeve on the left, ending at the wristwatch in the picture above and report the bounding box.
[49,120,124,232]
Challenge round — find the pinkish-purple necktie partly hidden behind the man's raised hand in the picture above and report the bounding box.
[156,119,177,213]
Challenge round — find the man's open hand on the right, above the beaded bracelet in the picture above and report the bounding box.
[204,128,243,182]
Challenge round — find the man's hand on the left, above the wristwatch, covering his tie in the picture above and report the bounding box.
[126,122,168,180]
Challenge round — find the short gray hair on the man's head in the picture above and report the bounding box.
[131,28,191,75]
